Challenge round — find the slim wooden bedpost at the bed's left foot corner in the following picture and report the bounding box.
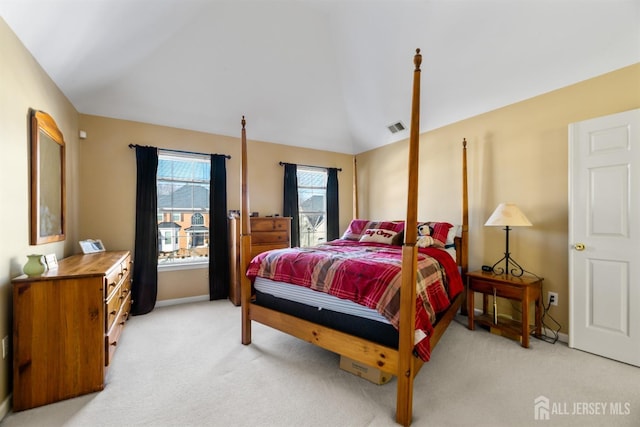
[240,116,251,345]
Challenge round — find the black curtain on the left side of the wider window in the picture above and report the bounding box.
[131,146,158,315]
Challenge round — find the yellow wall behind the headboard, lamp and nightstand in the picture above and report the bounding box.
[356,64,640,333]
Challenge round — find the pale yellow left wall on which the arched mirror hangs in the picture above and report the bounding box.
[0,18,78,417]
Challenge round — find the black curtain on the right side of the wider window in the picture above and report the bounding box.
[209,154,230,300]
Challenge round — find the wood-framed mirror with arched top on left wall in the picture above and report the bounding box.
[30,110,65,245]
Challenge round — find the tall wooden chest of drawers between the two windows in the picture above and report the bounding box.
[229,216,291,305]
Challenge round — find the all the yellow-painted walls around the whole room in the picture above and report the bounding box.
[0,9,640,417]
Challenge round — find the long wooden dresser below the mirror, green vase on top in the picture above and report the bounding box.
[13,251,132,411]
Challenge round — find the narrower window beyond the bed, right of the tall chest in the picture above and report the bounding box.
[297,166,327,247]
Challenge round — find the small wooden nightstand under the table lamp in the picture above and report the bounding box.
[467,271,543,347]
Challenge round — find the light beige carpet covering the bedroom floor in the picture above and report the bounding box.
[0,301,640,427]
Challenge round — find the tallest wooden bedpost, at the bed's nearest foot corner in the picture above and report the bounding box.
[396,49,422,426]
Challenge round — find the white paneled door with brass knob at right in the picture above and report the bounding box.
[569,109,640,366]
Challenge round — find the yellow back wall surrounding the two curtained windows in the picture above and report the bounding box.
[79,114,353,300]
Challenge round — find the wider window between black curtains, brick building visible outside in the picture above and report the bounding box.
[157,150,211,266]
